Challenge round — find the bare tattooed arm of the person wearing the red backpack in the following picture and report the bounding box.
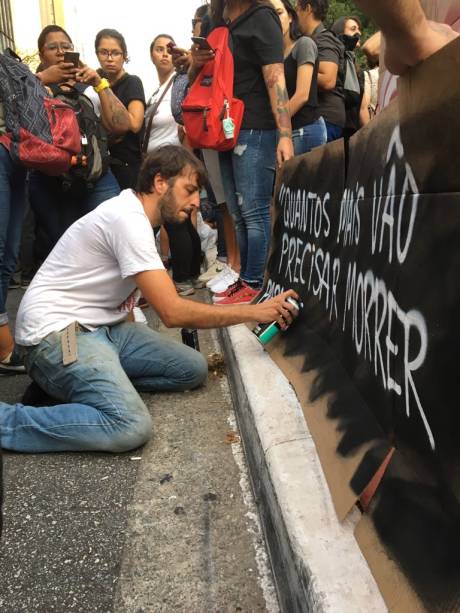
[262,64,294,166]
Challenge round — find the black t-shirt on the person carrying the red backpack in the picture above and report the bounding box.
[230,6,284,130]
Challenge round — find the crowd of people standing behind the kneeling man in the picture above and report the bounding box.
[0,0,378,362]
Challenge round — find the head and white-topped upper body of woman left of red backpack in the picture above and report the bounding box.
[145,34,180,151]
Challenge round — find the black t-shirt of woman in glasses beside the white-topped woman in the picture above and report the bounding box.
[110,74,145,164]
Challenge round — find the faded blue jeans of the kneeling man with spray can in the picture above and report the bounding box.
[0,322,208,453]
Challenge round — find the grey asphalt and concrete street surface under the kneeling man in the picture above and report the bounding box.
[0,290,278,613]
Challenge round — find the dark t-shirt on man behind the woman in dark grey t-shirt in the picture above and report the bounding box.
[312,24,345,128]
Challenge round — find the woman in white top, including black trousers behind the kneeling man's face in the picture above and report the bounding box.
[144,34,204,296]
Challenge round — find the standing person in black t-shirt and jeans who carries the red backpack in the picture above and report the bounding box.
[189,0,294,305]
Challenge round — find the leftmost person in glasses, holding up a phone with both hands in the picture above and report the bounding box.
[29,25,125,257]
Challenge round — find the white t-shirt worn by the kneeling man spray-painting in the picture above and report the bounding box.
[16,189,164,345]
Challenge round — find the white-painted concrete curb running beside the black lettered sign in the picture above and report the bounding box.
[220,326,387,613]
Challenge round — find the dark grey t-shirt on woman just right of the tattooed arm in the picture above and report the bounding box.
[284,36,320,130]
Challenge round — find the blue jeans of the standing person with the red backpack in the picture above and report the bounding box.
[219,130,277,287]
